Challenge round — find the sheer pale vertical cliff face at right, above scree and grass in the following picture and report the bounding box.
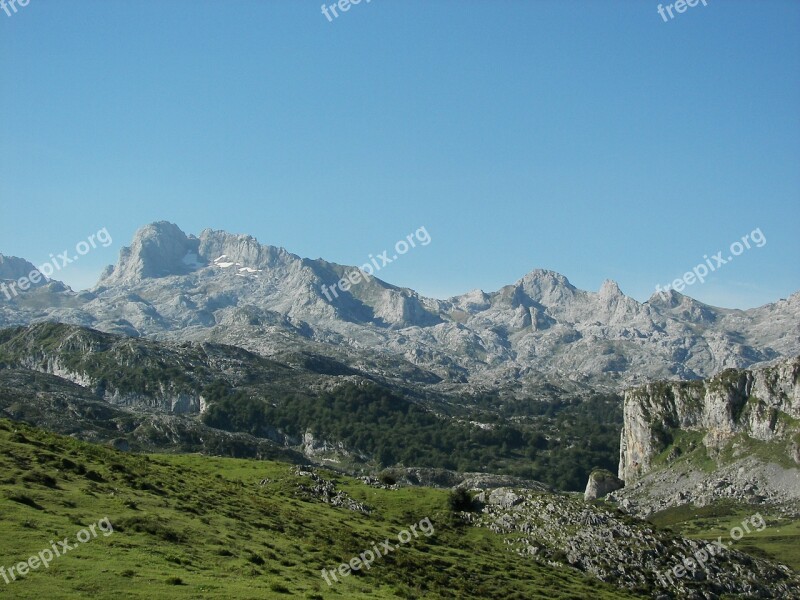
[619,357,800,484]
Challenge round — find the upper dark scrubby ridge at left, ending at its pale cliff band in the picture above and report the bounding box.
[0,323,324,415]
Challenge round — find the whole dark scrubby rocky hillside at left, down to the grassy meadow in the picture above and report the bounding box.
[0,323,372,458]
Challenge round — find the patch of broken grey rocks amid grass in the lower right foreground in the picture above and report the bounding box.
[461,489,800,600]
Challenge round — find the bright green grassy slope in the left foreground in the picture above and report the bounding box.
[0,420,638,600]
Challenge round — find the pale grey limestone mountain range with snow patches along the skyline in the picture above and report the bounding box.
[0,221,800,393]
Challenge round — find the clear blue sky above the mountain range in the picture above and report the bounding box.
[0,0,800,308]
